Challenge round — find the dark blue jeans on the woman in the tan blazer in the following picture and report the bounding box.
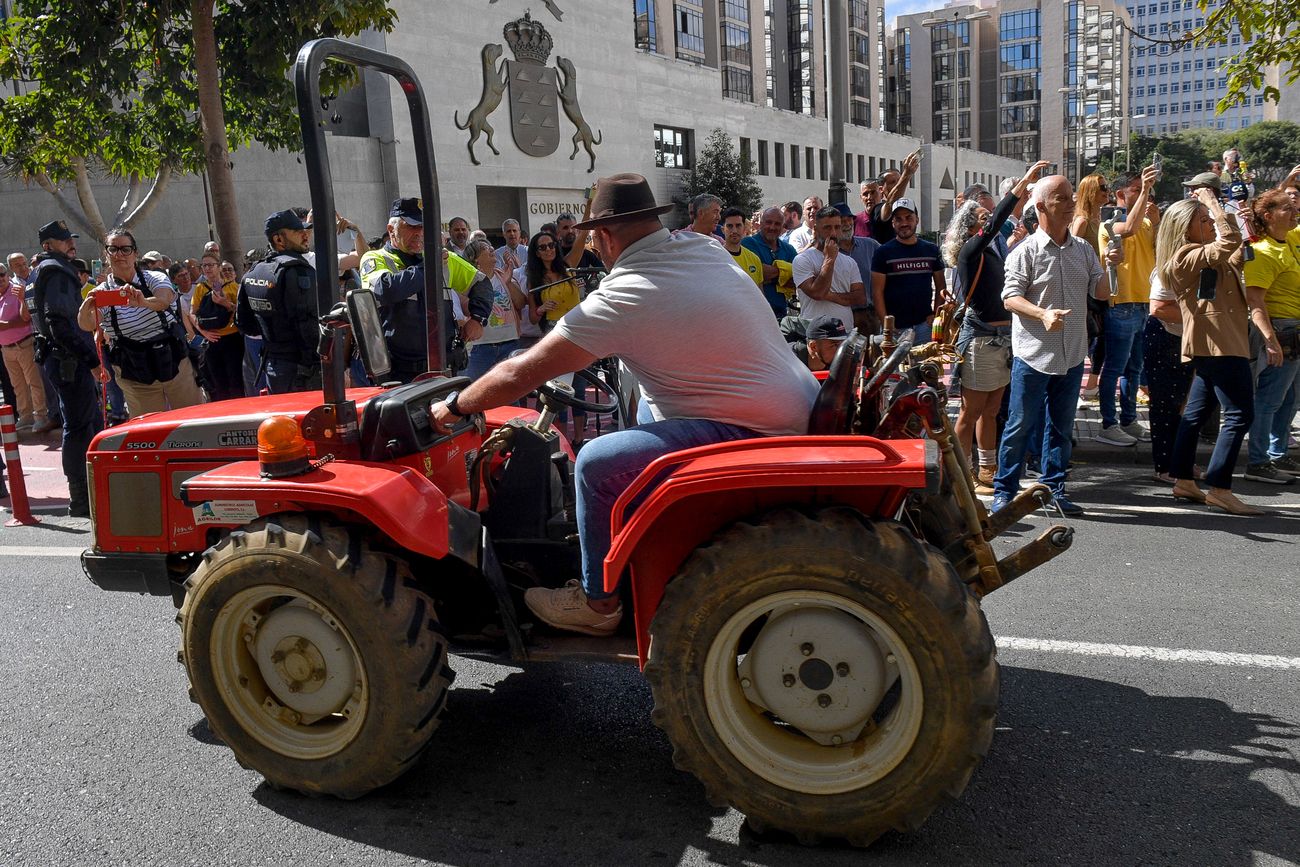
[1169,355,1255,489]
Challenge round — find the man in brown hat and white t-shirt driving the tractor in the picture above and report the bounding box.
[433,174,818,636]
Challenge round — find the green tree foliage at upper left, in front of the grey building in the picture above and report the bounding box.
[0,0,395,252]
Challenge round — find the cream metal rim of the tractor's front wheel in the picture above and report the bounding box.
[209,585,369,760]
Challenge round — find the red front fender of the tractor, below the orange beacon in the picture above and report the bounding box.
[181,460,482,568]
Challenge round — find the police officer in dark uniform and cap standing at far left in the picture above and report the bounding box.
[31,220,103,517]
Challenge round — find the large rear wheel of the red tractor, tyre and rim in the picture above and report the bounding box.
[646,508,998,846]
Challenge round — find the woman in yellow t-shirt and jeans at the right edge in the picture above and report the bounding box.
[1244,190,1300,485]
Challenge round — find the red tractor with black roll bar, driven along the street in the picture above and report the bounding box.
[83,39,1071,845]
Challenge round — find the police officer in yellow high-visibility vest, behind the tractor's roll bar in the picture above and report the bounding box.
[360,199,493,382]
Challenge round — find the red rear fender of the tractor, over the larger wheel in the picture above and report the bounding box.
[605,437,941,666]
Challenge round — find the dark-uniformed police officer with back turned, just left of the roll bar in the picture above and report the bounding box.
[235,211,321,394]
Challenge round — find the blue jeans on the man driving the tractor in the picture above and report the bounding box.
[575,419,761,599]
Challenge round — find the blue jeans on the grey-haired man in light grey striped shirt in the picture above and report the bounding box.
[993,359,1083,497]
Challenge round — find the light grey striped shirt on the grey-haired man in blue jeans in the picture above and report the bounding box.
[1002,226,1101,376]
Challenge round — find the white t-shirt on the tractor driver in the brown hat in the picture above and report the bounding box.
[555,229,818,435]
